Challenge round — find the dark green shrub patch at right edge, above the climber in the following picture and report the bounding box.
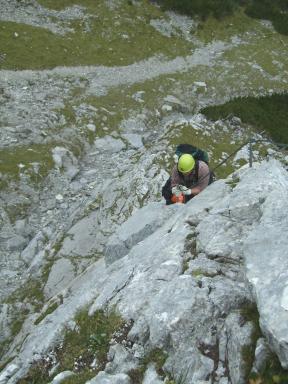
[201,93,288,144]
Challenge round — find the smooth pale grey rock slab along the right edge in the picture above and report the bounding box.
[244,161,288,369]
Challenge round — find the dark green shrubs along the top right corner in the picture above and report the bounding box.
[160,0,288,35]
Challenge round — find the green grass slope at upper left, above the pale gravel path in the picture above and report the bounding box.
[0,0,192,70]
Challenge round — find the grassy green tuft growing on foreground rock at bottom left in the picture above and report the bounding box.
[18,310,126,384]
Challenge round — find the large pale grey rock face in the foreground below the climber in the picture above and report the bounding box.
[0,161,288,384]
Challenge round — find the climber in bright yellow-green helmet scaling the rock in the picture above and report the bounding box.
[162,153,212,205]
